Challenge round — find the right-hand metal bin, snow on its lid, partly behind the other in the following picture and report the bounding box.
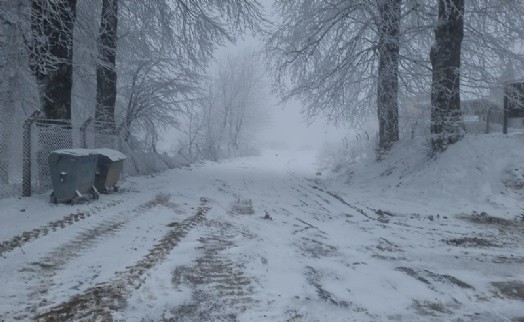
[91,149,127,193]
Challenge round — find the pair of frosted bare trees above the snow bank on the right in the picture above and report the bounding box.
[267,0,524,153]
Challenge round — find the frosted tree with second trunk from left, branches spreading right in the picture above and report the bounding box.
[52,0,263,151]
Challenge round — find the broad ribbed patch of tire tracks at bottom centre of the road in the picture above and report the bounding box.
[170,221,254,321]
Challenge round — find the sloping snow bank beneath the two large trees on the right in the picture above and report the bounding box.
[330,134,524,217]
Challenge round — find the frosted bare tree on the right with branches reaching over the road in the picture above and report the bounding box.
[267,0,420,154]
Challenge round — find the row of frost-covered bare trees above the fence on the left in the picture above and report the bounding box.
[0,0,264,151]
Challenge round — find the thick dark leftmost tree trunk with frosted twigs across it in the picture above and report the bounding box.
[31,0,76,119]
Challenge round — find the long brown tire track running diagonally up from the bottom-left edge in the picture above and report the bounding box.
[34,205,210,321]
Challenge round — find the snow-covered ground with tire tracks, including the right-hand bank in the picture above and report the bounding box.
[0,135,524,321]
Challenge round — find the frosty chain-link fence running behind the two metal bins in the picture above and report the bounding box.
[0,114,183,198]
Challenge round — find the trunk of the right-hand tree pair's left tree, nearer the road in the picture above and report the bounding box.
[377,0,402,156]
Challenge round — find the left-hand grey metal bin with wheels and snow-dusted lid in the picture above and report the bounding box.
[48,149,98,203]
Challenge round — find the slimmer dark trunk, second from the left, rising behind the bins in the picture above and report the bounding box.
[95,0,118,129]
